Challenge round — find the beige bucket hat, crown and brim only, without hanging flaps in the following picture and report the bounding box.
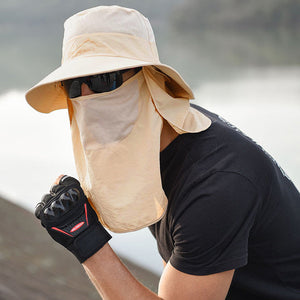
[25,5,194,113]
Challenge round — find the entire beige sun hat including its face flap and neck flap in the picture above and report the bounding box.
[26,6,210,232]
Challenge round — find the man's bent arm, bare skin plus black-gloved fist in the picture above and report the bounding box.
[35,176,233,300]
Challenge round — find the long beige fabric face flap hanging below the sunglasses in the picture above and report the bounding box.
[67,72,167,232]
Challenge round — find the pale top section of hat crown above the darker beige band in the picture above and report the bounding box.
[63,5,155,44]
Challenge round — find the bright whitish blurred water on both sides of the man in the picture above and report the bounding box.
[0,68,300,273]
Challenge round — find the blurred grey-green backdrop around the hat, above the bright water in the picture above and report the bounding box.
[0,0,300,93]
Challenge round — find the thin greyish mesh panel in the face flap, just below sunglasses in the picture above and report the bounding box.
[72,75,139,145]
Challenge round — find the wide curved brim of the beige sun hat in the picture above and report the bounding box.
[25,55,194,113]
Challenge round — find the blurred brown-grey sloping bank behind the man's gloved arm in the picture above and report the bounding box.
[0,198,159,300]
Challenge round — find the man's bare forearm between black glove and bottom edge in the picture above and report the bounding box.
[83,243,161,300]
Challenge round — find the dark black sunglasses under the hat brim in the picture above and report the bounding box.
[62,68,141,98]
